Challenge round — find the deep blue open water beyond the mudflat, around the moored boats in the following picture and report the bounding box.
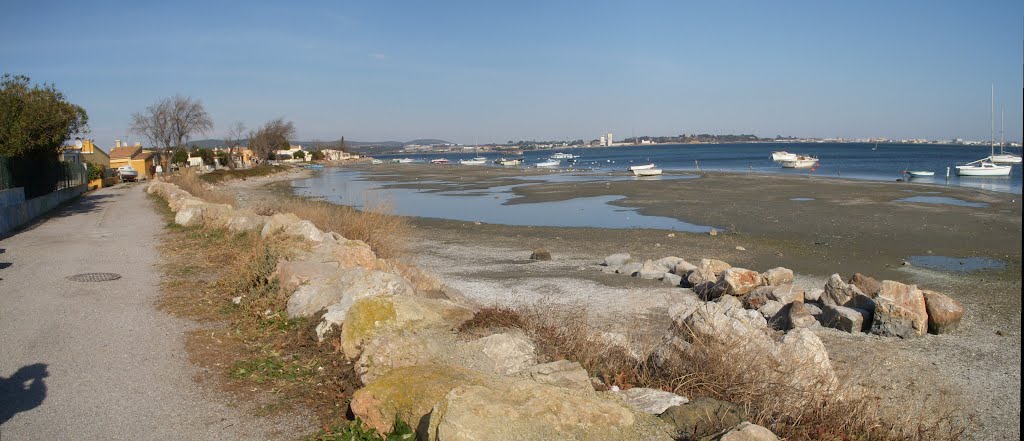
[380,143,1022,193]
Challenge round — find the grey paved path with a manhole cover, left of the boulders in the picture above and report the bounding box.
[0,185,299,441]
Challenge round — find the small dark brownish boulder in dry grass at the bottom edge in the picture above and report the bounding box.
[658,397,746,440]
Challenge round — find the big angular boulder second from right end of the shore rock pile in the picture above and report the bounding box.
[871,280,928,339]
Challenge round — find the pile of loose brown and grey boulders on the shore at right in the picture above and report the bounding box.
[601,254,964,339]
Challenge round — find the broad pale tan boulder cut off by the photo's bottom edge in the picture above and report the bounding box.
[427,380,671,441]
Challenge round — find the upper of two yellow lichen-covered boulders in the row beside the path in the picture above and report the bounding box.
[341,296,473,359]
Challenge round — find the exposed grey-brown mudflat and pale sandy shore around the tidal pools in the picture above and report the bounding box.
[230,164,1021,439]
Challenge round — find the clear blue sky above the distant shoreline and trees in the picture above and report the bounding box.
[0,0,1024,145]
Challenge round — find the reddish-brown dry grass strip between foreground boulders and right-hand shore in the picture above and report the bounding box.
[460,305,971,441]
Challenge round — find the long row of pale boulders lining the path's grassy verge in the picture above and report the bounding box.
[147,180,782,440]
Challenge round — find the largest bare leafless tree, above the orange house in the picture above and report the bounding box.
[131,95,213,161]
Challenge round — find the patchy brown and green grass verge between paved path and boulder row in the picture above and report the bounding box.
[149,197,359,425]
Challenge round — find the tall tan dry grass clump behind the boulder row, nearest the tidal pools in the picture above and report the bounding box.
[265,197,411,259]
